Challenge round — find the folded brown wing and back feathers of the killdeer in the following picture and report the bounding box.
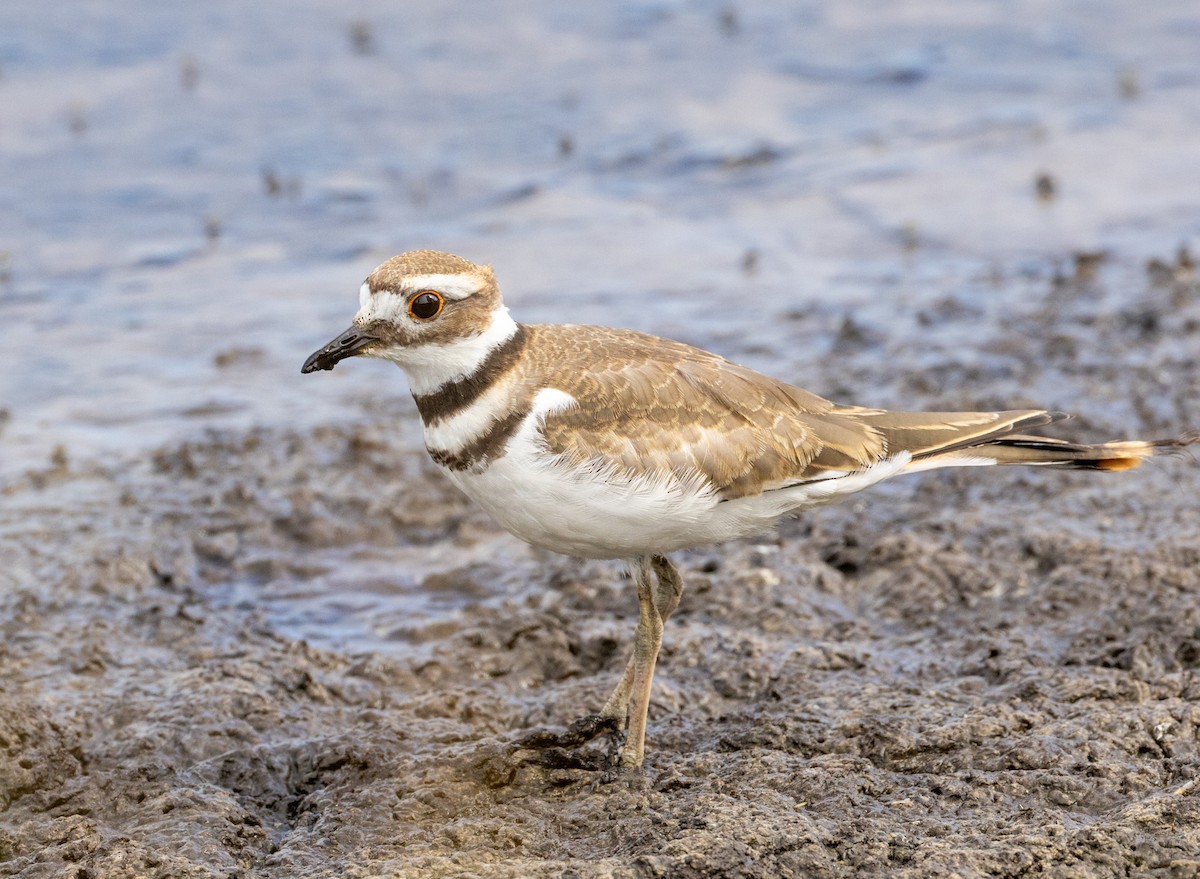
[528,327,1044,498]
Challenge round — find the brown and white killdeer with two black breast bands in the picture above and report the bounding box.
[302,251,1200,767]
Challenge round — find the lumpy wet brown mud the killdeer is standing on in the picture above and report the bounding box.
[0,264,1200,877]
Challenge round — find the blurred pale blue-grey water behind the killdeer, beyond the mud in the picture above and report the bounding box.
[0,0,1200,479]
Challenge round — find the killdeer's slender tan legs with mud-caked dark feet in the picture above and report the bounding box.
[514,555,683,769]
